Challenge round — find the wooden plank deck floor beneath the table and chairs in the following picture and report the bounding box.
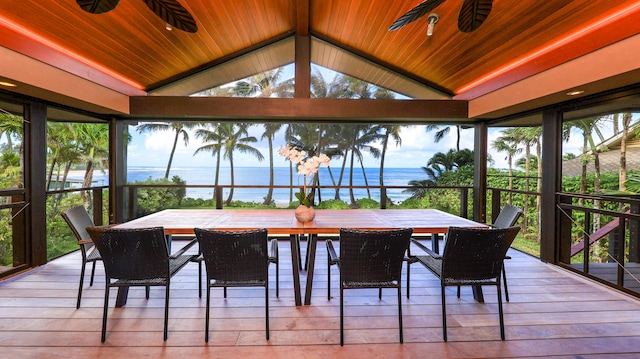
[0,242,640,359]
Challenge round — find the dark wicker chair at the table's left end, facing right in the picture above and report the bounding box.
[62,206,102,309]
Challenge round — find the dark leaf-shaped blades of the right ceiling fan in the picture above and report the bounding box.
[389,0,493,32]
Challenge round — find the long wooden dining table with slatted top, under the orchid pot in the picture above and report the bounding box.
[115,209,486,306]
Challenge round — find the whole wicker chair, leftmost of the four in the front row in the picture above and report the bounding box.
[87,227,196,343]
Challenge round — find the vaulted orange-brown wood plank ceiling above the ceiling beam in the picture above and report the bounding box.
[0,0,640,99]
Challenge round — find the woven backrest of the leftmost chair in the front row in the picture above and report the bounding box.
[87,227,169,280]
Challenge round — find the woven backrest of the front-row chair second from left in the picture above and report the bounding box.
[194,228,269,282]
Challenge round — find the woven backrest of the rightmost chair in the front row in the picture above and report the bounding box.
[442,227,520,282]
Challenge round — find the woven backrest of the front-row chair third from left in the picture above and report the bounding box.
[340,228,413,283]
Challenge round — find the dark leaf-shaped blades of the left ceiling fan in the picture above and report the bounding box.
[76,0,198,33]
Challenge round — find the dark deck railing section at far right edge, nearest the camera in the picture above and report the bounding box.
[558,193,640,296]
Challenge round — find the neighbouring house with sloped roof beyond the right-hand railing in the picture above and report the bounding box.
[562,130,640,177]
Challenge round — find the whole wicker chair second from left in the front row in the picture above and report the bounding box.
[194,228,279,342]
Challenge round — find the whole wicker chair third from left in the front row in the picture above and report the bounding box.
[326,228,413,345]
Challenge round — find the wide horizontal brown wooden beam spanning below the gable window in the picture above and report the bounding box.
[130,96,471,123]
